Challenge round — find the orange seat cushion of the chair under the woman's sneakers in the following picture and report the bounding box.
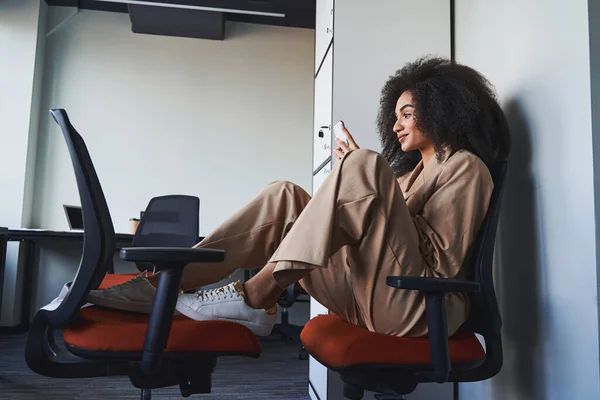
[63,274,262,357]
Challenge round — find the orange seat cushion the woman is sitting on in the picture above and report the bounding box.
[300,314,485,369]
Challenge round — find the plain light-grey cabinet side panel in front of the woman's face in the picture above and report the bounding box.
[333,0,450,156]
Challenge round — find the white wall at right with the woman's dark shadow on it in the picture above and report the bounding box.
[456,0,600,400]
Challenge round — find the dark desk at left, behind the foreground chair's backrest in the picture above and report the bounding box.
[0,228,133,326]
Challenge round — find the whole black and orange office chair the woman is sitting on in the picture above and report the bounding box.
[301,162,507,400]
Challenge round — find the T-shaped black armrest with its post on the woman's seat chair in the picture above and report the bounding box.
[386,276,481,383]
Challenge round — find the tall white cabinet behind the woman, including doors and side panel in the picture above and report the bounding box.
[309,0,450,400]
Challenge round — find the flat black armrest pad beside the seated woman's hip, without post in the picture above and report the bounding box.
[386,276,481,293]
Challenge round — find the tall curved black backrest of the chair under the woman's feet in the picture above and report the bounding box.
[46,109,116,327]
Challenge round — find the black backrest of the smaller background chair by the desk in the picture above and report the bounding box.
[133,195,200,271]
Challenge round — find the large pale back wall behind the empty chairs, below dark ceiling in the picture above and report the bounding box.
[28,8,314,307]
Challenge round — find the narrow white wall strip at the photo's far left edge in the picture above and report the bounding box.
[0,0,46,325]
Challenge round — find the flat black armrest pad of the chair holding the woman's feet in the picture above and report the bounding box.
[121,247,225,268]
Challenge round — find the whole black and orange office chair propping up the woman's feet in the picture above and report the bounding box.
[25,110,262,399]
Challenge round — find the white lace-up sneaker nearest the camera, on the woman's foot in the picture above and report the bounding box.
[175,281,277,336]
